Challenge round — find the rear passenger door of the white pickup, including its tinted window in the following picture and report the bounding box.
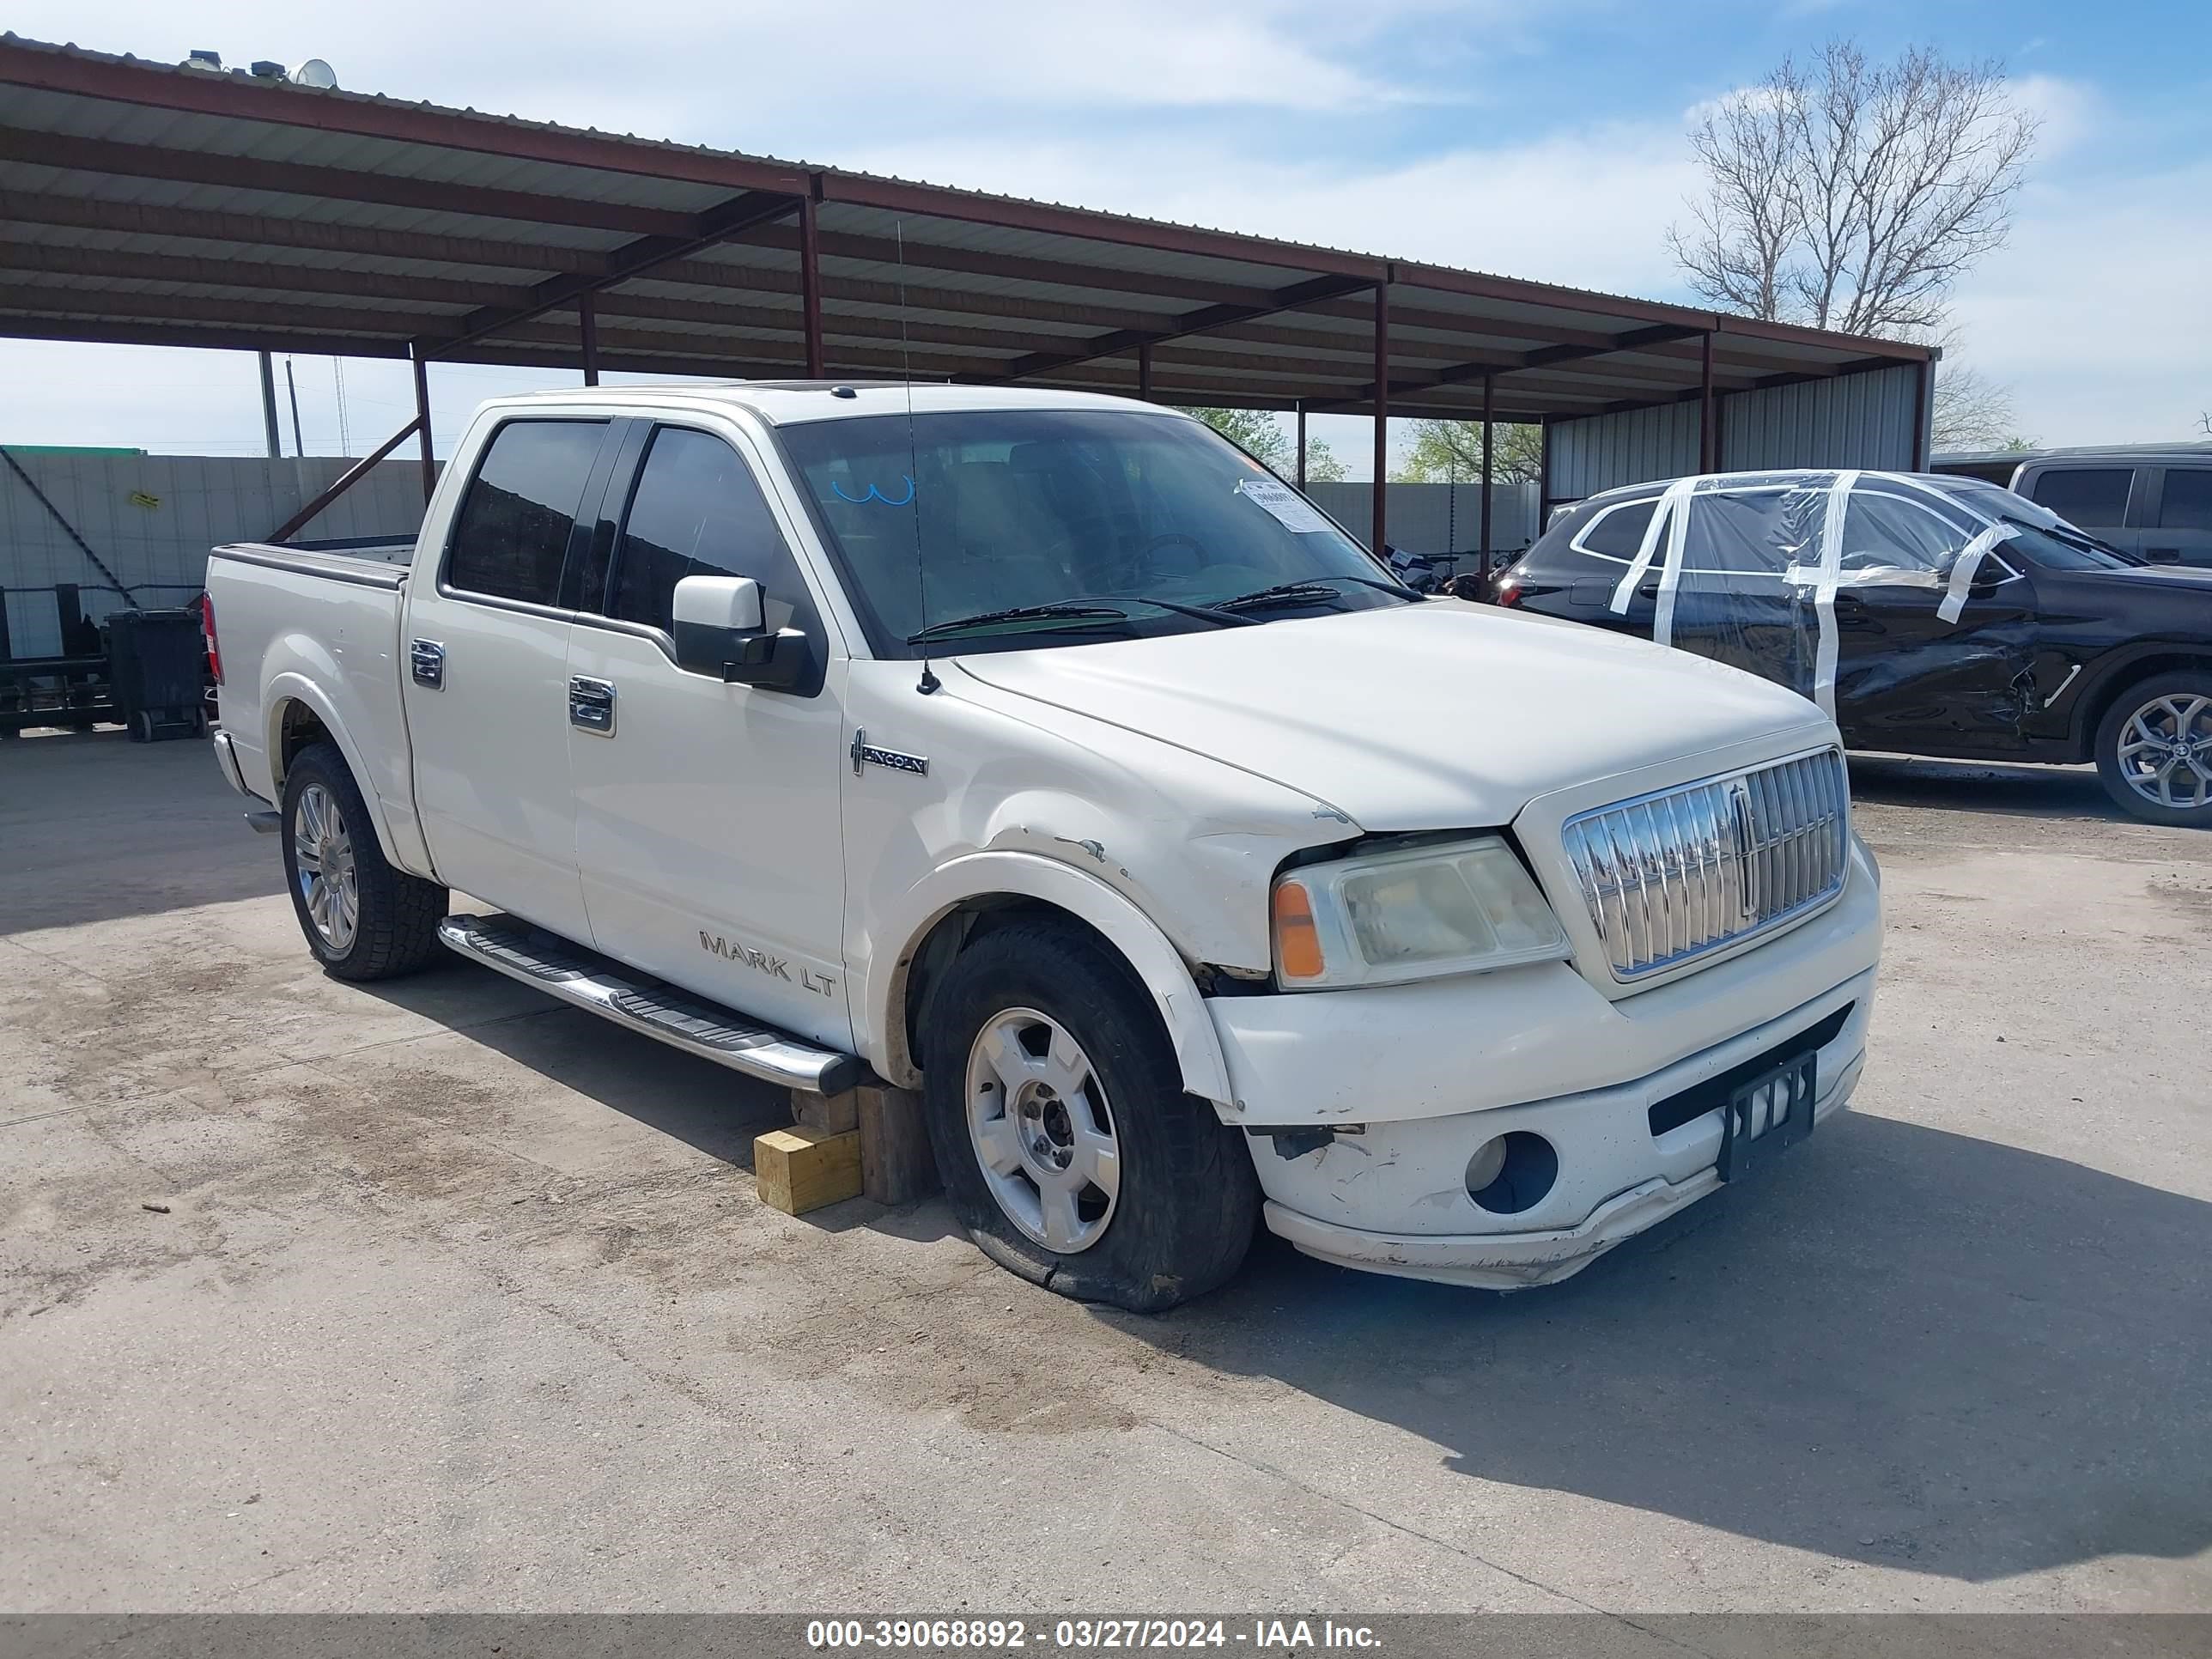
[398,418,608,938]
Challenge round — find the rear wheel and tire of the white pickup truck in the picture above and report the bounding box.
[283,744,449,980]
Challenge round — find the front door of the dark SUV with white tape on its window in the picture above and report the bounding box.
[1836,480,2035,754]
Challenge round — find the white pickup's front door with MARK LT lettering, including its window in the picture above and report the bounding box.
[566,425,852,1048]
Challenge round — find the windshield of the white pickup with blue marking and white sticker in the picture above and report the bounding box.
[776,410,1413,657]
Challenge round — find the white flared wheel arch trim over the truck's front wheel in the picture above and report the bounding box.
[863,852,1234,1106]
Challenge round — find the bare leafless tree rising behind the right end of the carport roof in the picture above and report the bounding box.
[1668,40,2037,337]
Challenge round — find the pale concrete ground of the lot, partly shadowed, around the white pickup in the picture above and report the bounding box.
[0,734,2212,1613]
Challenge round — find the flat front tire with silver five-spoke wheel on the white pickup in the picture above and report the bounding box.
[922,921,1259,1314]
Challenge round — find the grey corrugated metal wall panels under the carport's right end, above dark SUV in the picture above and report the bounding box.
[1548,362,1924,502]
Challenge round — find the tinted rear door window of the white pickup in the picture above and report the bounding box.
[445,420,606,604]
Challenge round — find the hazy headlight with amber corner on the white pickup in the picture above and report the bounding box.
[1274,836,1566,991]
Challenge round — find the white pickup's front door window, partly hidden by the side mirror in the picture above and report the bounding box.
[615,427,818,635]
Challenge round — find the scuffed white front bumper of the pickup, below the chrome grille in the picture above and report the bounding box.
[1207,842,1881,1290]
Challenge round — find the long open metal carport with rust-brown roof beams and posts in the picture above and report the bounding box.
[0,35,1933,566]
